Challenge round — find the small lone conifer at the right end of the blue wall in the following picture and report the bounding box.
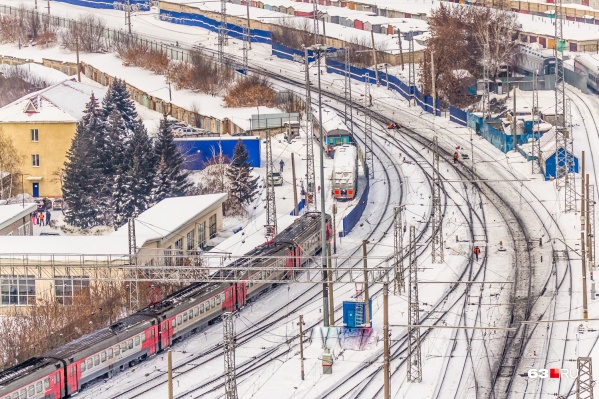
[227,140,258,205]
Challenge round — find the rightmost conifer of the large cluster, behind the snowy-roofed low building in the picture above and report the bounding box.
[151,114,192,204]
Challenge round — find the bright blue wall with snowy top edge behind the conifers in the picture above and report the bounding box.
[175,136,260,170]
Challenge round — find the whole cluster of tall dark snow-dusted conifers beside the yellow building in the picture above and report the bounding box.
[63,79,191,228]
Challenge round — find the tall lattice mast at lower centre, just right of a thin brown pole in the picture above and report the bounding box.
[407,226,422,382]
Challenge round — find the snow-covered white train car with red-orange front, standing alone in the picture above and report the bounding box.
[332,144,358,200]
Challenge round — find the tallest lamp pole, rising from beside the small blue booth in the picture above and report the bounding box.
[310,44,329,327]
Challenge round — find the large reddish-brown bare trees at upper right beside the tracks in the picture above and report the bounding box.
[420,4,517,106]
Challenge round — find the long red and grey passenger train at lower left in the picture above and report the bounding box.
[0,213,332,399]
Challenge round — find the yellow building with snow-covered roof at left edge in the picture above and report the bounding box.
[0,80,106,197]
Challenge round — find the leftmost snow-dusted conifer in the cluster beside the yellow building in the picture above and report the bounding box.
[62,93,104,228]
